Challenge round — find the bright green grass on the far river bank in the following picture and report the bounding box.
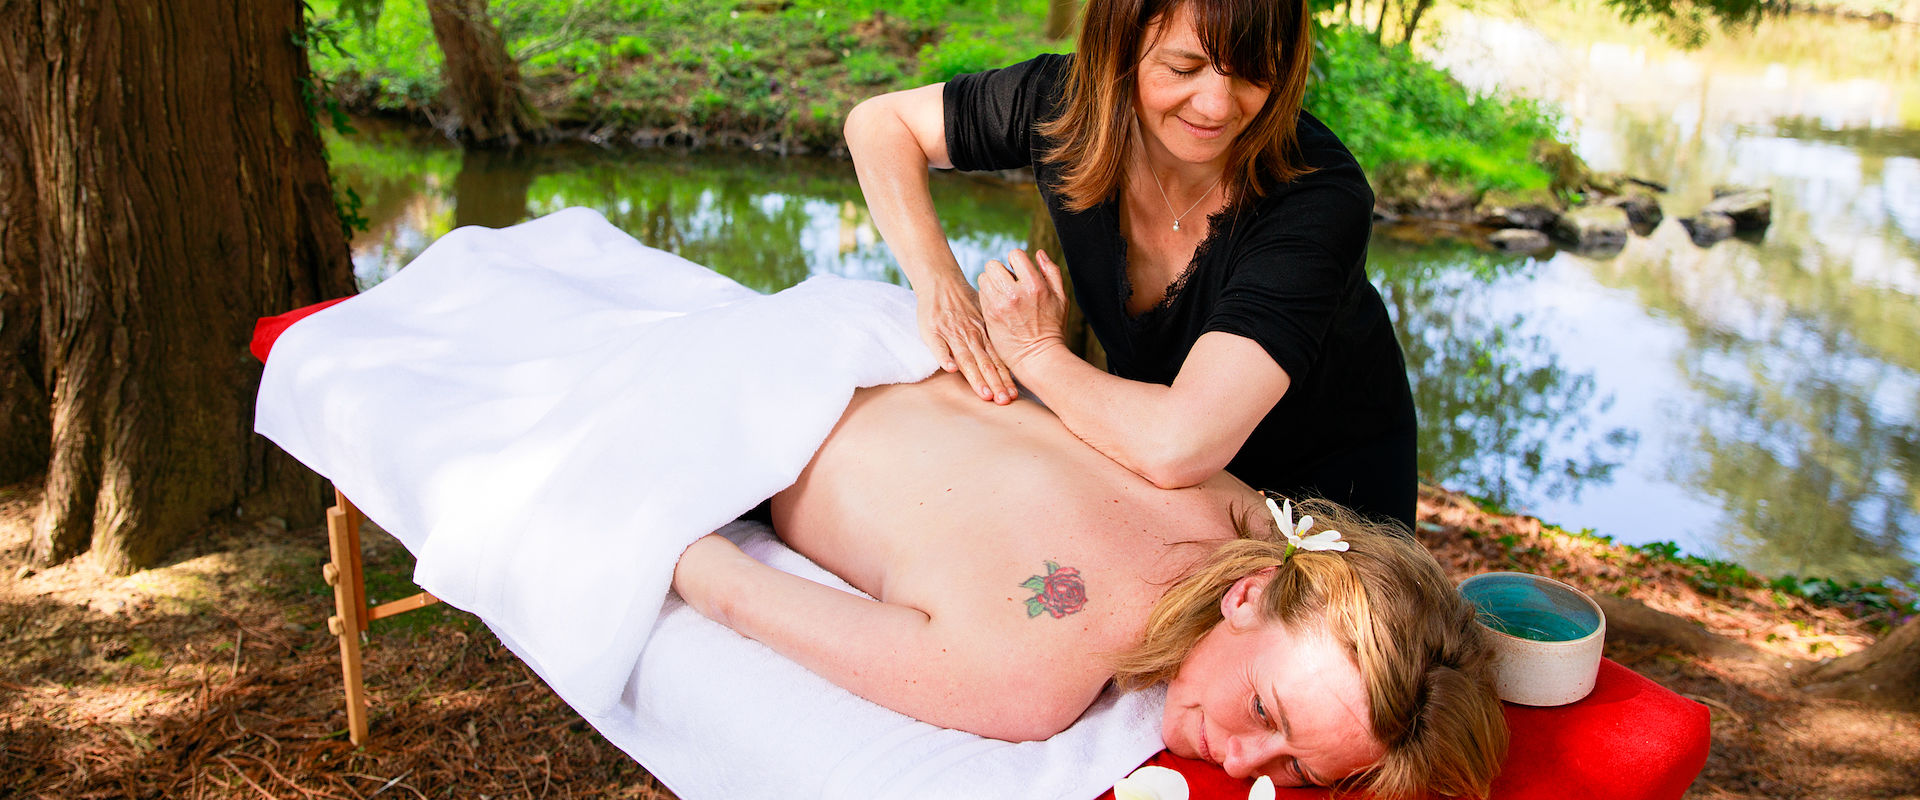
[313,0,1555,194]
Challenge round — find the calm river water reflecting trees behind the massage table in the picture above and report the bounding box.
[332,12,1920,579]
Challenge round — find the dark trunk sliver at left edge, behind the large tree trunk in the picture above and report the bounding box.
[0,56,54,485]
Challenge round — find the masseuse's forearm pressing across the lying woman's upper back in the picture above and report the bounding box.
[1014,341,1236,489]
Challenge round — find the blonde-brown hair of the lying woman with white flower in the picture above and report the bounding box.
[1116,501,1507,800]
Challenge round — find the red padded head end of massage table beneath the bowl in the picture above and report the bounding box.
[1100,660,1711,800]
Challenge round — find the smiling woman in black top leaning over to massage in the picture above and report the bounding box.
[847,0,1415,526]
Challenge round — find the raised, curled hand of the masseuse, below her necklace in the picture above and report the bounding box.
[979,249,1068,372]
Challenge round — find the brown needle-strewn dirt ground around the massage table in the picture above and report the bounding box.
[0,483,1920,800]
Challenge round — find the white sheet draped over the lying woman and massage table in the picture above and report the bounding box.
[255,209,1160,800]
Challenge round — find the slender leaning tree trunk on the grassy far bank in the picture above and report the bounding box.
[426,0,547,148]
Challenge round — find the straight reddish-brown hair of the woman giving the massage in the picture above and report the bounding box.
[1039,0,1313,213]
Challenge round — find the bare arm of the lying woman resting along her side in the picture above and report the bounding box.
[674,535,1098,741]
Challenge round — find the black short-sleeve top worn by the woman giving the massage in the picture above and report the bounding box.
[945,56,1415,491]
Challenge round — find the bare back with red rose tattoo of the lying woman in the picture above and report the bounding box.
[756,374,1258,735]
